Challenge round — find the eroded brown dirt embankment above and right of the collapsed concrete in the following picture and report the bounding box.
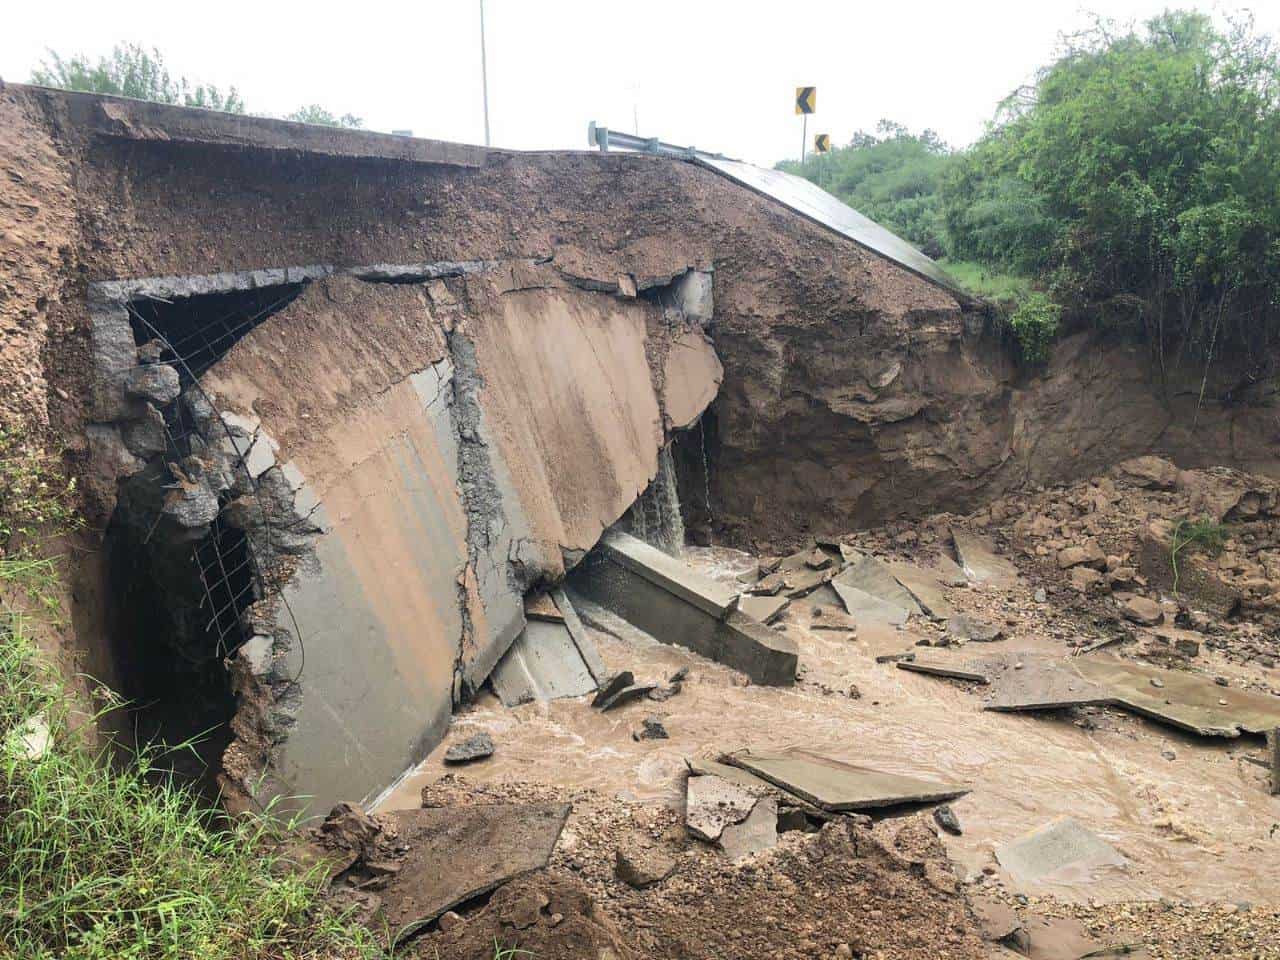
[0,88,1277,552]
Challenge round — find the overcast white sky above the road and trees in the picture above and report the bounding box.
[0,0,1280,165]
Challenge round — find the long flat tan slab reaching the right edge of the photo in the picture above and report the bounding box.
[1071,654,1280,737]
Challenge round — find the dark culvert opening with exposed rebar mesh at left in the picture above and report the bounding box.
[104,283,303,794]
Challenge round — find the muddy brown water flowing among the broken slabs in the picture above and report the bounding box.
[379,549,1280,902]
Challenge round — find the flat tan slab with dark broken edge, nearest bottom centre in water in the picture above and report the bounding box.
[726,750,969,810]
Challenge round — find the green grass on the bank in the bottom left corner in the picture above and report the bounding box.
[0,430,384,960]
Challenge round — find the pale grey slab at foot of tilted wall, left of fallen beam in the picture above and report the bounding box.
[489,619,596,707]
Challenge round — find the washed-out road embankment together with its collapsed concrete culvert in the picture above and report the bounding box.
[0,87,1271,808]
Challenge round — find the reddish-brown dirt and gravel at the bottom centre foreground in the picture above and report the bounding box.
[404,777,984,960]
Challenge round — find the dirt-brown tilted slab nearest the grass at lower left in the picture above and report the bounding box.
[381,804,570,940]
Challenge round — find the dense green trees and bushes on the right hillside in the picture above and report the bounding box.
[783,12,1280,362]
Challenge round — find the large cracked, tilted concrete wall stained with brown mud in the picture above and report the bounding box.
[193,264,719,812]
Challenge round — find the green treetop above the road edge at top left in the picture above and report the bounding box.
[31,44,244,114]
